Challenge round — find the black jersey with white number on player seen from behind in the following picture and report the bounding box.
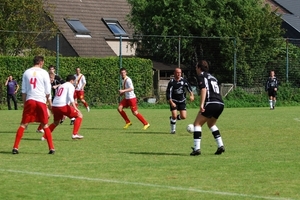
[198,72,223,104]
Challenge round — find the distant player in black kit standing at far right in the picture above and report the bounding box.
[265,70,279,110]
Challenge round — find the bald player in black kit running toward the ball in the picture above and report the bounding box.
[166,68,194,134]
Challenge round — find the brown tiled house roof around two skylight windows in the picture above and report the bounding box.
[46,0,131,57]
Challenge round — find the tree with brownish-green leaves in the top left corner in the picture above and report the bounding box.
[0,0,57,56]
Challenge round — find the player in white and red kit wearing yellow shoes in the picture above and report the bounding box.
[118,68,150,130]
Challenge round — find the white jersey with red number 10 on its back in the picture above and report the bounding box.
[52,82,75,107]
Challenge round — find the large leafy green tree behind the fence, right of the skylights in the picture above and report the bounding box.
[128,0,283,84]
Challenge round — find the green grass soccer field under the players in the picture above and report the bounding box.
[0,107,300,200]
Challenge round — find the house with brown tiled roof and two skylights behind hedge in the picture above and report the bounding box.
[41,0,135,57]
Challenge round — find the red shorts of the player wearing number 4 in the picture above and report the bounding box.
[22,100,48,124]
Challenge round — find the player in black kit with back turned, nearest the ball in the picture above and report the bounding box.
[190,60,225,156]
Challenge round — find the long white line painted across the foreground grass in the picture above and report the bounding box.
[0,169,293,200]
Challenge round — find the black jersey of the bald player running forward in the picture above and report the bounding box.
[166,77,192,103]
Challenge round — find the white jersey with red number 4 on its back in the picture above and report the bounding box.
[22,67,51,103]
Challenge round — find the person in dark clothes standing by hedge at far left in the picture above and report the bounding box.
[5,76,20,110]
